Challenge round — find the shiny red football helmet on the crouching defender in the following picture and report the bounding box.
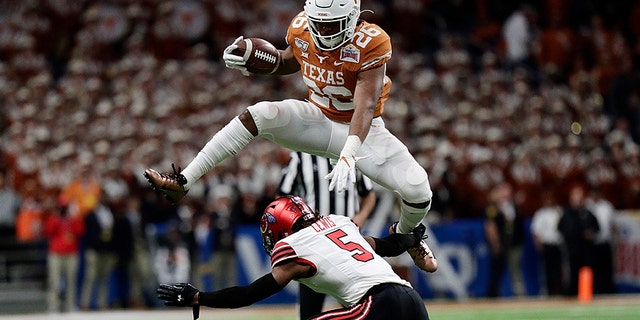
[260,196,319,255]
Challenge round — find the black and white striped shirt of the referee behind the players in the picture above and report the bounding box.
[278,152,373,218]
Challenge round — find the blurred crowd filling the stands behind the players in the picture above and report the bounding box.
[0,0,640,307]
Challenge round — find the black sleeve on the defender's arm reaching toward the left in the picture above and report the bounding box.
[198,273,282,308]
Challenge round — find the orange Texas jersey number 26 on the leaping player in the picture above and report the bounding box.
[286,12,391,122]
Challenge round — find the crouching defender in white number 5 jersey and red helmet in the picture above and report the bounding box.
[157,196,429,320]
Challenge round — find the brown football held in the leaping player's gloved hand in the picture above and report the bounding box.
[232,38,280,74]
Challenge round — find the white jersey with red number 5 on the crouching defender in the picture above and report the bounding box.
[271,215,411,307]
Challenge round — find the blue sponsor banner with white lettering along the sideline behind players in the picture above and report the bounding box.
[236,212,640,303]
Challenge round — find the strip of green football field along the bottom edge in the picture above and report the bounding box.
[0,295,640,320]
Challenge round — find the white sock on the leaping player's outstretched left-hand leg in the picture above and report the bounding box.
[182,117,253,190]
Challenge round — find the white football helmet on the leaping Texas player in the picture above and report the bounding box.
[304,0,360,51]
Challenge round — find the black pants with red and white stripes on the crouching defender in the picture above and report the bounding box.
[309,283,429,320]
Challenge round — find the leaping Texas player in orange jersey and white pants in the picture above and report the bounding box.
[145,0,437,272]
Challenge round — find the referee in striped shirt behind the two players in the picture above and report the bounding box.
[278,152,376,319]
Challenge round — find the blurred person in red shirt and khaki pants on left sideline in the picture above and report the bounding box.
[44,197,85,312]
